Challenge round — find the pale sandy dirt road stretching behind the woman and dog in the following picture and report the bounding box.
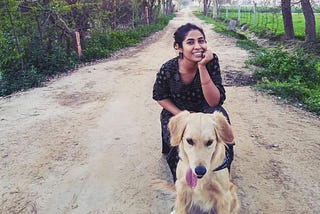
[0,10,320,214]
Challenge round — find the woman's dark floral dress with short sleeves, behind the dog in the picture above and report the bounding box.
[153,54,229,181]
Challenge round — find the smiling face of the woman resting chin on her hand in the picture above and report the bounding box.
[179,30,207,62]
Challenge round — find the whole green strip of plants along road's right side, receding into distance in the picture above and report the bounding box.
[195,12,320,115]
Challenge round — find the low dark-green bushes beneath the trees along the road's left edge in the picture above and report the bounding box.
[0,13,173,96]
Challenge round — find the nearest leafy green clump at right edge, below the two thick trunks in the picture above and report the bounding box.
[248,47,320,114]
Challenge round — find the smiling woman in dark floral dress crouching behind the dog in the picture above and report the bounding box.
[153,23,233,181]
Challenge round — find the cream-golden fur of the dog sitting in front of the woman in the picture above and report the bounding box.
[154,111,240,214]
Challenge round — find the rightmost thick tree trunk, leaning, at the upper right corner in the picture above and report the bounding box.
[301,0,316,42]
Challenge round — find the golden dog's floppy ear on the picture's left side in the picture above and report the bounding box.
[168,111,190,146]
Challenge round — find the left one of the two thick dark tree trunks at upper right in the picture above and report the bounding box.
[281,0,294,40]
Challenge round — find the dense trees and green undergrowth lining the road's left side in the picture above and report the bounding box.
[0,0,173,96]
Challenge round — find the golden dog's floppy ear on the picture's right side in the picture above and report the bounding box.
[213,112,234,144]
